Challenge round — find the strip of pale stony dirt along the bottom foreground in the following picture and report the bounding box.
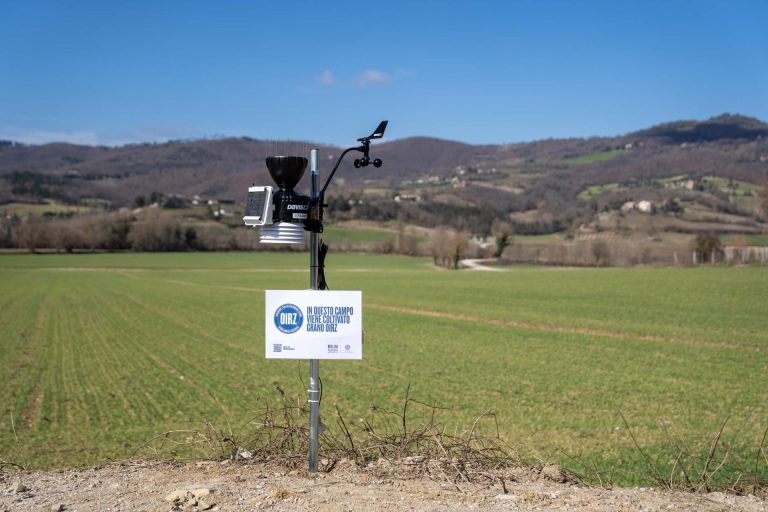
[0,459,768,512]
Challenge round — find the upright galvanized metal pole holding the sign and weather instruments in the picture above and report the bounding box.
[308,149,322,473]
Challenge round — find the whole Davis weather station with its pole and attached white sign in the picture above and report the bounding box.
[243,121,387,473]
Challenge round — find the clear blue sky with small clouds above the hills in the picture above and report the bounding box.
[0,0,768,145]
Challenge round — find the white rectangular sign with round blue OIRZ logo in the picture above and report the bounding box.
[264,290,363,359]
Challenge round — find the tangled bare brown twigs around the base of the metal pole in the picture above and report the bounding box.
[133,386,523,490]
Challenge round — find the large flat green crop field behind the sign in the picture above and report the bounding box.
[0,253,768,484]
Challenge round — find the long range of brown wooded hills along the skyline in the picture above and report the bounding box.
[0,114,768,238]
